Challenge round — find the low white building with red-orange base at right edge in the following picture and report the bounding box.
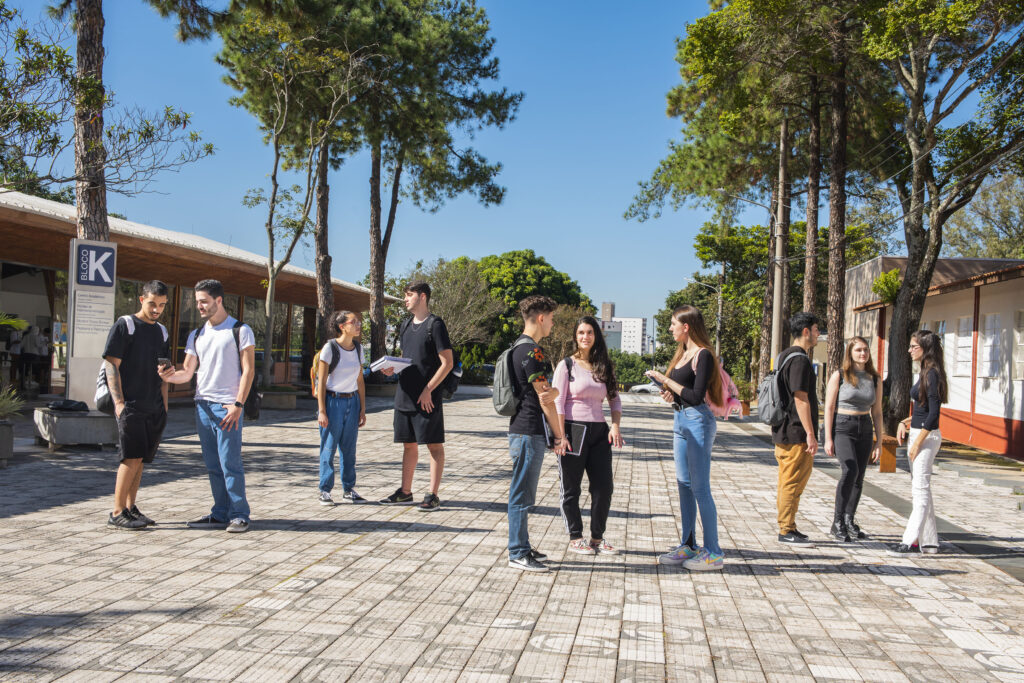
[844,256,1024,460]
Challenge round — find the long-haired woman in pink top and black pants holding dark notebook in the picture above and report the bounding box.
[551,315,624,555]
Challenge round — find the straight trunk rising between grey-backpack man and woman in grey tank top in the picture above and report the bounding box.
[826,26,849,374]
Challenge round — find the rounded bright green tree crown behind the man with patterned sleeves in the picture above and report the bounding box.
[480,249,596,358]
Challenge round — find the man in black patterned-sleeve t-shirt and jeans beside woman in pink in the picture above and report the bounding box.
[506,294,565,571]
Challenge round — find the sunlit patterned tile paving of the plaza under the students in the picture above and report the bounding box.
[0,397,1024,683]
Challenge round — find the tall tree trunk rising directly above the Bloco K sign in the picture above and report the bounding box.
[75,0,111,241]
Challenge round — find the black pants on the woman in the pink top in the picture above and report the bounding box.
[558,420,614,539]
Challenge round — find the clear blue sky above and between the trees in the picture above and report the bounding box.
[18,0,737,335]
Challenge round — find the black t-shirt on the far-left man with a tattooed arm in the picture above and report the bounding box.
[103,315,171,413]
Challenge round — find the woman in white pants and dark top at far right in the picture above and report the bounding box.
[889,330,948,556]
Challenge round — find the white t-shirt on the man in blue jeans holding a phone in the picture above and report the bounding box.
[185,315,256,405]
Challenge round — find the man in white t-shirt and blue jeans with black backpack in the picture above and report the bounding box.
[161,280,256,533]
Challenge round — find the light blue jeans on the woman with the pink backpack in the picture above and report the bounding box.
[672,404,722,554]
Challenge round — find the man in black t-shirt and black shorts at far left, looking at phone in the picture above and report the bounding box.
[103,280,170,529]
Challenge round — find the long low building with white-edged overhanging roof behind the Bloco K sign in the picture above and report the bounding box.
[0,193,390,393]
